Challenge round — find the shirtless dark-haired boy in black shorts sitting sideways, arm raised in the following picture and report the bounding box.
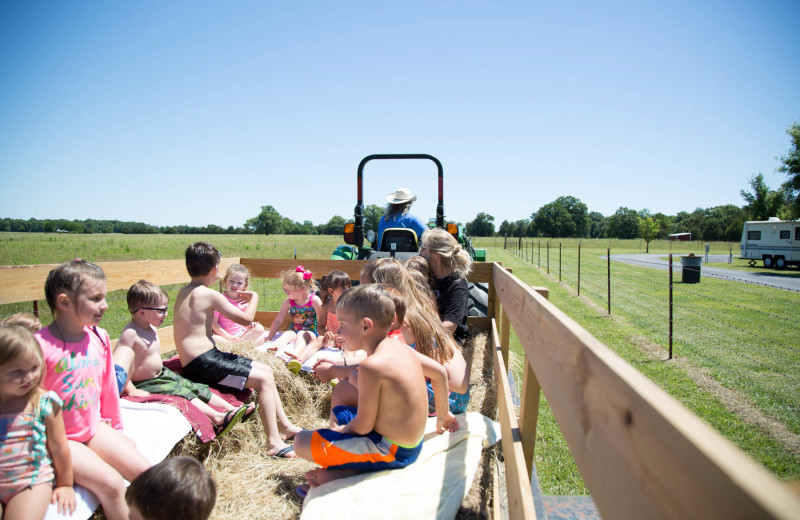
[173,242,300,458]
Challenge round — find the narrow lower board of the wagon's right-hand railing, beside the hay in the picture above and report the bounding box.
[492,320,536,519]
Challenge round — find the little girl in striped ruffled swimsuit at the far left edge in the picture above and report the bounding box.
[0,324,75,520]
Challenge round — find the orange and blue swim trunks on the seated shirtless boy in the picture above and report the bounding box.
[311,406,422,472]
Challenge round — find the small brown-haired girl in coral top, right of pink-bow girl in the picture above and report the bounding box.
[286,271,353,374]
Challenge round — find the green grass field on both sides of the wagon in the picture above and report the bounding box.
[0,233,800,494]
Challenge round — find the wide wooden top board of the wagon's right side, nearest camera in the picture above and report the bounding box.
[494,267,800,519]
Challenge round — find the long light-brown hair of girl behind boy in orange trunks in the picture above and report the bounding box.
[372,257,456,363]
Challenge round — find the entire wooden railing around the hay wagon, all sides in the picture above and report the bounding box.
[0,258,800,520]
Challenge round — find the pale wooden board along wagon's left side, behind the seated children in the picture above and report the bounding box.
[0,258,239,304]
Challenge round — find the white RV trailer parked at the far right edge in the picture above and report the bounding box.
[740,217,800,269]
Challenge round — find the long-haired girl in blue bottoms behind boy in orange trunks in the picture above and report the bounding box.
[371,258,469,414]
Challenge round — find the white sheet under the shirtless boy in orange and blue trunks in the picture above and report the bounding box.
[300,412,500,520]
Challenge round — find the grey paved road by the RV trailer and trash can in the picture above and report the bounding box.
[602,253,800,292]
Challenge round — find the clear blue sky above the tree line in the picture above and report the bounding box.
[0,0,800,230]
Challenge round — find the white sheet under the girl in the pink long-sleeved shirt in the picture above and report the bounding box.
[45,399,192,520]
